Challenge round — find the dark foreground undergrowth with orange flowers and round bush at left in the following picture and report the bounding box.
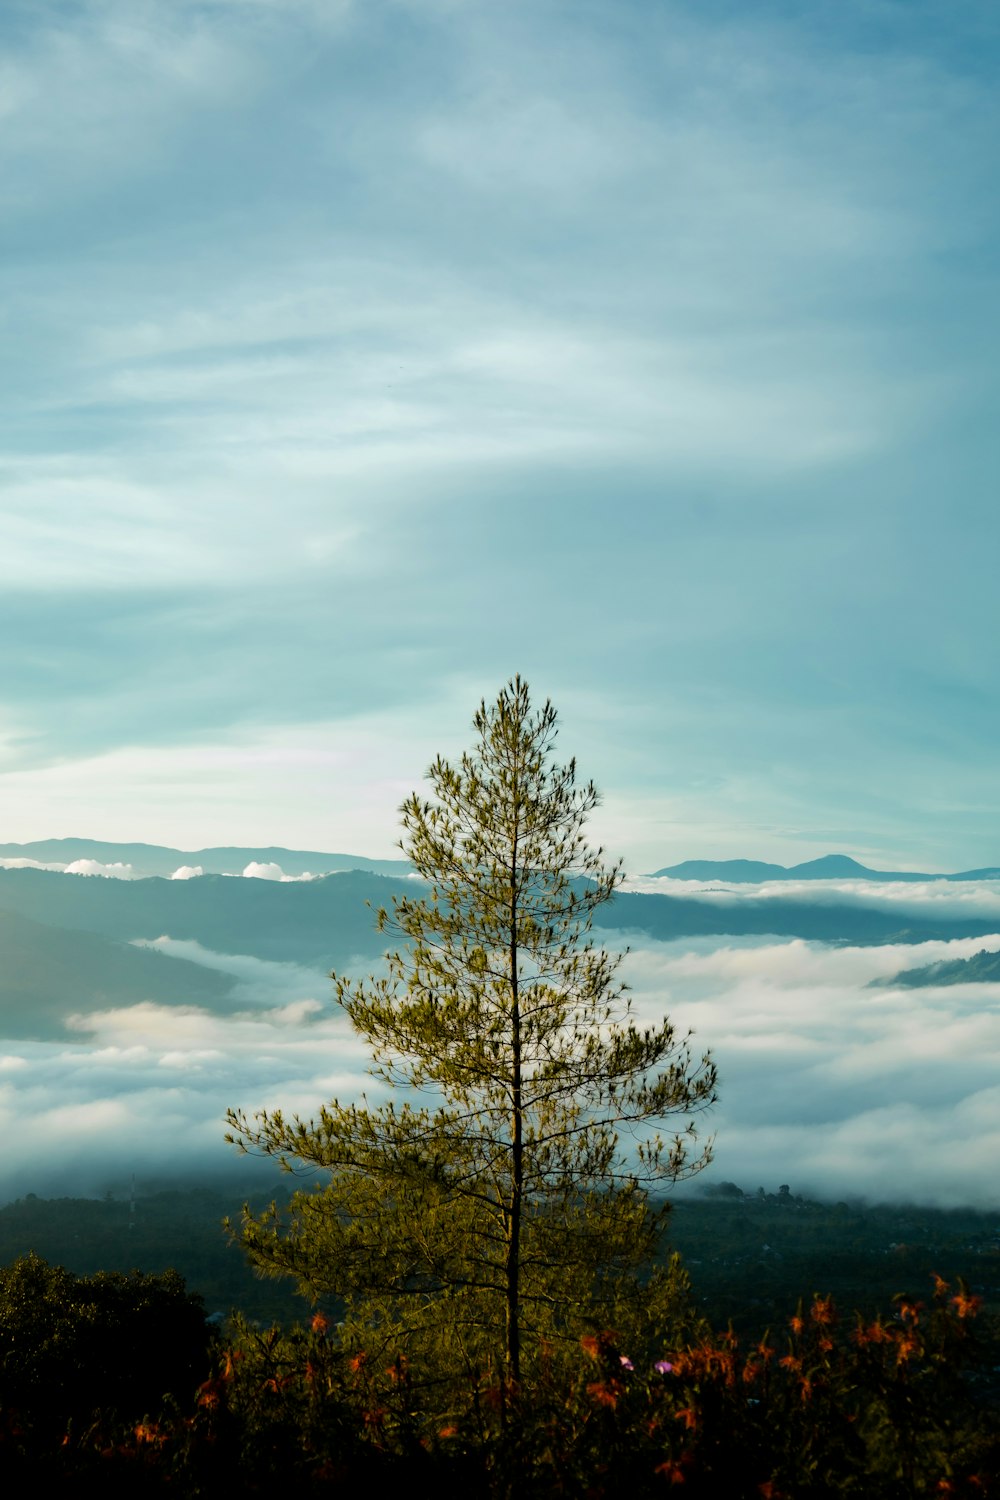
[0,1257,1000,1500]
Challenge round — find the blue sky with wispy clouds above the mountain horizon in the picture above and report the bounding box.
[0,0,1000,870]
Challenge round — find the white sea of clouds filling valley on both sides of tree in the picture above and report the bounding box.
[0,887,1000,1206]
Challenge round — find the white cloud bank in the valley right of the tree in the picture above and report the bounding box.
[617,935,1000,1205]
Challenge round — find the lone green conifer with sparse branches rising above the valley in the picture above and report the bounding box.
[226,677,715,1383]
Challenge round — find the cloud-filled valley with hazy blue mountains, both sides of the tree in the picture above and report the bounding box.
[0,840,1000,1208]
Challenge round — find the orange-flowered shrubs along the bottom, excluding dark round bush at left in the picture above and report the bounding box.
[0,1278,1000,1500]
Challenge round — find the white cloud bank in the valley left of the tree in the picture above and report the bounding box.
[0,938,379,1197]
